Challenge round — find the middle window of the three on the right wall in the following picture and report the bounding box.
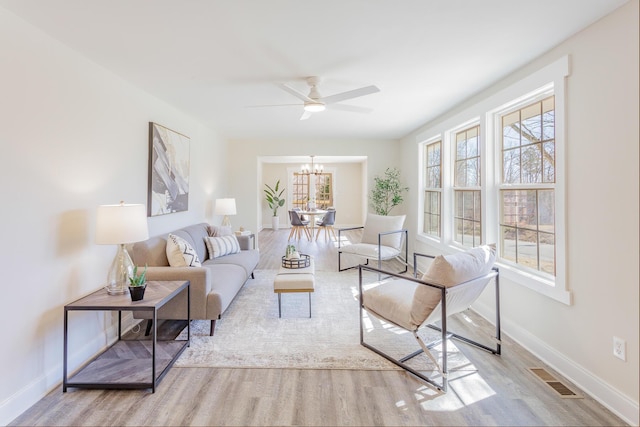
[453,126,482,247]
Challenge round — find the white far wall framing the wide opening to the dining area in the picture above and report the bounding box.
[229,140,400,239]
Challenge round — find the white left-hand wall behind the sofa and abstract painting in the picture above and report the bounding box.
[0,8,226,425]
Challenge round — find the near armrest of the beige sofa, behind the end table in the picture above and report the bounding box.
[147,267,211,313]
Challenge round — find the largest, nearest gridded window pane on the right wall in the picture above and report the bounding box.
[500,96,555,275]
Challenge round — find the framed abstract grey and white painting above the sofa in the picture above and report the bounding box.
[147,122,191,216]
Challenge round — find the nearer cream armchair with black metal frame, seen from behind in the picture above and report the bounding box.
[359,246,501,392]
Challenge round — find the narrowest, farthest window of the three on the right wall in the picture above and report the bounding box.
[423,140,442,237]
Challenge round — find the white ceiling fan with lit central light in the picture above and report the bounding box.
[251,76,380,120]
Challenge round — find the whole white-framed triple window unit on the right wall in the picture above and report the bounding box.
[417,56,572,305]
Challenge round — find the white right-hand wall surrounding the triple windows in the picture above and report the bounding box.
[402,1,640,425]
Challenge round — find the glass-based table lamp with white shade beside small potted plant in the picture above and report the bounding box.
[96,202,149,295]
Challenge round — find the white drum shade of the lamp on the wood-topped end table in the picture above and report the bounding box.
[96,203,149,245]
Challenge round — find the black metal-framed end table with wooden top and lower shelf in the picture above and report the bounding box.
[62,280,191,392]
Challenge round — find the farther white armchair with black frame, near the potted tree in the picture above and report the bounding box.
[338,214,408,273]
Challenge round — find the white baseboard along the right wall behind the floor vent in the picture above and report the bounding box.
[473,301,640,426]
